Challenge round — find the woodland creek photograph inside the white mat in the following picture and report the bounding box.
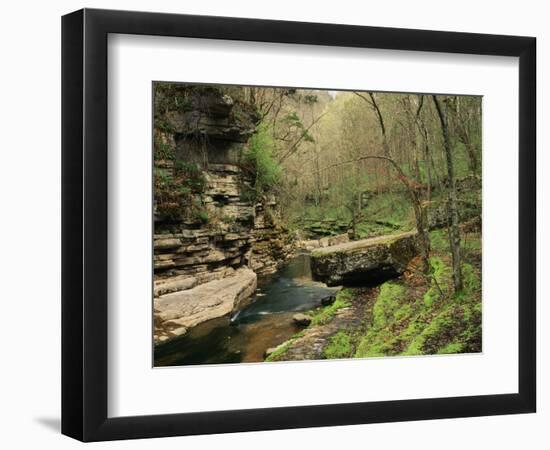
[152,81,482,367]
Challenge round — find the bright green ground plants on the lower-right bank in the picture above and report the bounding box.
[355,236,481,358]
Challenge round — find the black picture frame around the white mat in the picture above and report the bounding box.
[62,9,536,441]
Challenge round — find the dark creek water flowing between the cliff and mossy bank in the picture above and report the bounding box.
[155,254,335,366]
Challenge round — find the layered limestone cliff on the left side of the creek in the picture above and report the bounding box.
[153,83,294,337]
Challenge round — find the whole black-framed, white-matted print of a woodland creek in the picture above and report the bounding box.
[62,9,536,441]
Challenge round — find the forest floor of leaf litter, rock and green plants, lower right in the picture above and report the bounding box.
[266,230,481,361]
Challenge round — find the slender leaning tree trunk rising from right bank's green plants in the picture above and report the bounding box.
[432,95,462,292]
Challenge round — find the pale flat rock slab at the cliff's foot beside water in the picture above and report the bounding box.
[154,268,256,342]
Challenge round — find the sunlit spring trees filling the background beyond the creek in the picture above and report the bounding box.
[247,88,481,291]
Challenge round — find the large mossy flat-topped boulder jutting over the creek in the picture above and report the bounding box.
[311,232,418,286]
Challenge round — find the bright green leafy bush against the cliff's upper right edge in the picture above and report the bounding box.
[243,124,281,199]
